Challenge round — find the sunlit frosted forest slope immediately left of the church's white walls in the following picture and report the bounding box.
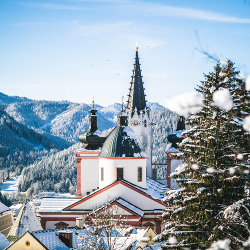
[19,143,80,195]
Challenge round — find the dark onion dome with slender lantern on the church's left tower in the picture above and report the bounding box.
[79,101,107,150]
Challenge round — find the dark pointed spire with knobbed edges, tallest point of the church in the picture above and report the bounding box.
[127,47,146,116]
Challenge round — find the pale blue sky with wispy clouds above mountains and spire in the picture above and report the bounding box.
[0,0,250,105]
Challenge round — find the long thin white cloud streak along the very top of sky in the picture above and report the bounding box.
[22,0,250,24]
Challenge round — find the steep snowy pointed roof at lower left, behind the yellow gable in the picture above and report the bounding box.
[8,203,42,236]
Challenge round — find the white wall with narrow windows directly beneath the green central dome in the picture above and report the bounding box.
[99,157,147,189]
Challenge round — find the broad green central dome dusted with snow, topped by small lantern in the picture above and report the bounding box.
[99,111,146,157]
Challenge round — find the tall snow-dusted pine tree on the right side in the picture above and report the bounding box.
[159,61,249,248]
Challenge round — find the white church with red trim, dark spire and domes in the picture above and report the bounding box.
[39,48,168,233]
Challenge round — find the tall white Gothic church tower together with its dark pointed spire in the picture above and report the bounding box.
[126,47,152,178]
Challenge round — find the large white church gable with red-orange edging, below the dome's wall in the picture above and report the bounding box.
[64,181,166,211]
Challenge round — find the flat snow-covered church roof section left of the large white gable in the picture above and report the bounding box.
[39,198,80,212]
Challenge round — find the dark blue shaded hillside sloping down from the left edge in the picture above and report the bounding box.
[0,108,70,174]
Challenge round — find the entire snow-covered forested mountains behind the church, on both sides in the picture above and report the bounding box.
[0,94,177,195]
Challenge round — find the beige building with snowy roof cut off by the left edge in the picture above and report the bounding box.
[0,202,14,236]
